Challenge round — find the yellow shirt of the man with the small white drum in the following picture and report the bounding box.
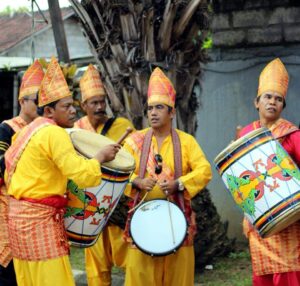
[124,128,212,200]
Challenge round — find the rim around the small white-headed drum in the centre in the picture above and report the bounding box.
[129,198,188,257]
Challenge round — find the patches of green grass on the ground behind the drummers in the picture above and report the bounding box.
[70,247,252,286]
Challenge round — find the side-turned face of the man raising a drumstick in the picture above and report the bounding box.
[50,96,76,128]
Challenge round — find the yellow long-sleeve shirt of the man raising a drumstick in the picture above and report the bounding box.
[8,125,101,199]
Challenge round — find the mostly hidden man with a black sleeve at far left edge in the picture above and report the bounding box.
[0,60,44,286]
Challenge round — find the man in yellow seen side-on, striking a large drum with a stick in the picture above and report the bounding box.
[5,58,120,286]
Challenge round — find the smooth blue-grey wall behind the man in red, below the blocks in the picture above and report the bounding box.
[196,46,300,240]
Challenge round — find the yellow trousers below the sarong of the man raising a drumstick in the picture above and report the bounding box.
[13,256,75,286]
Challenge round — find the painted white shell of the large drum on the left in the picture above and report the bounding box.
[65,166,131,247]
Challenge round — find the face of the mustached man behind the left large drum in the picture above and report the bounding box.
[82,95,106,121]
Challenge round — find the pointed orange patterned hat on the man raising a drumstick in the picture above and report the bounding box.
[39,57,71,107]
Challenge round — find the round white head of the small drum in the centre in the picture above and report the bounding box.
[130,200,187,256]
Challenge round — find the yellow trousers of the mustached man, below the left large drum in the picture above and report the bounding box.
[85,224,128,286]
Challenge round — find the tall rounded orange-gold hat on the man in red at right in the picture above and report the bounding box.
[257,58,289,97]
